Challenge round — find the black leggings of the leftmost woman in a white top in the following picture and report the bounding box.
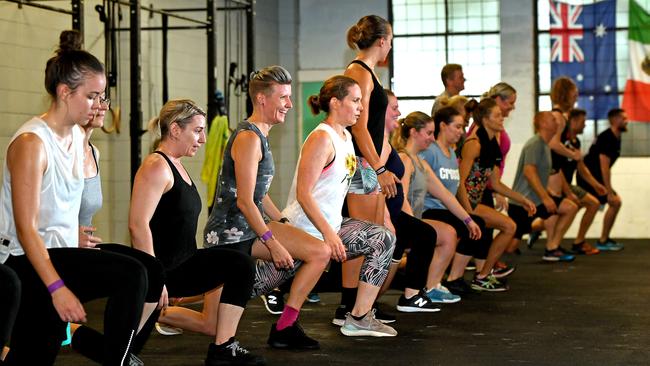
[5,248,147,365]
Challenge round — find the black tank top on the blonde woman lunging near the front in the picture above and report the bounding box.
[149,151,201,271]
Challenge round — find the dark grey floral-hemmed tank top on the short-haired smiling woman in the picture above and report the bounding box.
[203,121,275,247]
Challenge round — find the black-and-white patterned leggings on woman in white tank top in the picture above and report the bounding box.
[251,218,395,298]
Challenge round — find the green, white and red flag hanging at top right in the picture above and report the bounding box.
[623,0,650,122]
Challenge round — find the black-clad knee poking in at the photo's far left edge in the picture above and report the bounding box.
[0,263,20,346]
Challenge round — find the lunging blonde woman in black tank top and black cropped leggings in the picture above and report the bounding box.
[129,100,264,365]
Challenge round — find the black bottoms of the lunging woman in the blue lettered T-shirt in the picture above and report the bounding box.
[422,209,492,259]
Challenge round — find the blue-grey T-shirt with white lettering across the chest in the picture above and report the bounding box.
[420,142,460,210]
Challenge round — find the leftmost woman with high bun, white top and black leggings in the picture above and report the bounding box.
[0,31,147,365]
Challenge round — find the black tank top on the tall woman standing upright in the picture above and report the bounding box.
[348,60,388,156]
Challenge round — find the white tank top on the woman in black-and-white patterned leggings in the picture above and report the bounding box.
[282,123,357,240]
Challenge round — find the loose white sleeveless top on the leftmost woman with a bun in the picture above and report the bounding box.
[0,117,84,255]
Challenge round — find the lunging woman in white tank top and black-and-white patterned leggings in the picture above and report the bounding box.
[283,75,397,337]
